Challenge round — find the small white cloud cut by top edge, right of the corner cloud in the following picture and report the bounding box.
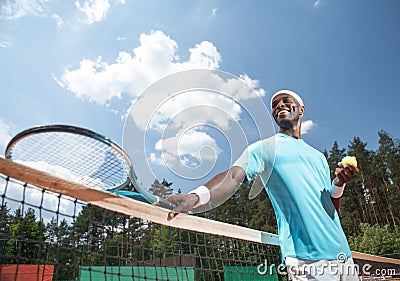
[75,0,111,25]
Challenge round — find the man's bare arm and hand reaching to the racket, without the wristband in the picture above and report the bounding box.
[166,166,246,219]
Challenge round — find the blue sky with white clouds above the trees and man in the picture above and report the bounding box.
[0,0,400,197]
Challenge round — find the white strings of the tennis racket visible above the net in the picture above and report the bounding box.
[11,132,129,189]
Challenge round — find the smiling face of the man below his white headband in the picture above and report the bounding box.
[272,94,304,129]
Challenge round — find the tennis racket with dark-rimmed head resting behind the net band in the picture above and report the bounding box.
[5,125,175,209]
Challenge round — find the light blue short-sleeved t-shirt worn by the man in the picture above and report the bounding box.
[234,133,351,260]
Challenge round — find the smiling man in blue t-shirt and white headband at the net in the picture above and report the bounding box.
[167,90,358,280]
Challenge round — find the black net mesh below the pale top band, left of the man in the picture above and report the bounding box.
[0,159,286,281]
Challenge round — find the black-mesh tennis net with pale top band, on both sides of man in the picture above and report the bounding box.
[0,158,400,281]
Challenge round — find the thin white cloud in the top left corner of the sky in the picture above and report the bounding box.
[0,0,48,20]
